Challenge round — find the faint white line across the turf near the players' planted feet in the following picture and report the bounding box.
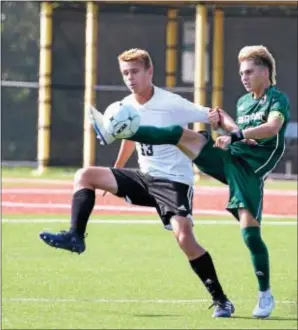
[2,297,297,305]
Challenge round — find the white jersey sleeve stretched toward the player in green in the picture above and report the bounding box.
[171,95,210,126]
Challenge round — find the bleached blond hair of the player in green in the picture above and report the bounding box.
[238,45,276,85]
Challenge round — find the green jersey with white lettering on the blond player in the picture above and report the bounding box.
[229,86,289,177]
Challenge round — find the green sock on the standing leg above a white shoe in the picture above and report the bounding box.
[241,227,270,291]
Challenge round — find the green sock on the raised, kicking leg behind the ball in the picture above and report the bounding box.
[129,125,183,145]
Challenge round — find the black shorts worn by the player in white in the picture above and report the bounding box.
[111,168,193,229]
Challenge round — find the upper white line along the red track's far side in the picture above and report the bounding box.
[2,186,297,197]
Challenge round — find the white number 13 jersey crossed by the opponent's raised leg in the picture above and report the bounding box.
[123,86,209,185]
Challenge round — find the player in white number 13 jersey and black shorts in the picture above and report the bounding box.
[40,49,234,317]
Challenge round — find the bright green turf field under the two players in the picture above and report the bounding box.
[2,215,297,329]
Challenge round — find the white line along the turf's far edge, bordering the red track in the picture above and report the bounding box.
[2,219,297,226]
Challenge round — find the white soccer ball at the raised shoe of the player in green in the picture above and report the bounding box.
[103,101,141,139]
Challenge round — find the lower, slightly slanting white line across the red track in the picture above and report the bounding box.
[1,202,297,219]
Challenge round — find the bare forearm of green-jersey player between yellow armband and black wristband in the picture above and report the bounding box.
[242,110,285,139]
